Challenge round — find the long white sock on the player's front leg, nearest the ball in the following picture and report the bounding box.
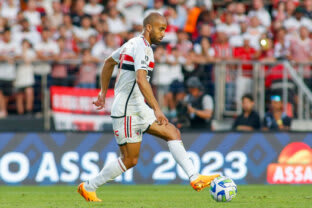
[167,140,199,181]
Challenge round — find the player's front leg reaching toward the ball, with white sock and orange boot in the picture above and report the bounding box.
[147,122,220,191]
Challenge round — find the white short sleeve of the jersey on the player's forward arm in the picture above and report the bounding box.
[133,41,149,71]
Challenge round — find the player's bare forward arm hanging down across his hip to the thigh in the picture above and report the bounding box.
[136,69,168,125]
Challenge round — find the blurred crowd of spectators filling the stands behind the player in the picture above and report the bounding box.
[0,0,312,130]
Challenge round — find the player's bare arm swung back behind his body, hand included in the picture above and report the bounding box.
[93,56,118,110]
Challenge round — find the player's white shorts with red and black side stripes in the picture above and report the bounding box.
[113,108,156,146]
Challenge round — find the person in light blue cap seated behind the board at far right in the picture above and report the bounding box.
[263,95,291,131]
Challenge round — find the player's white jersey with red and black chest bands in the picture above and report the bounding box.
[111,35,154,118]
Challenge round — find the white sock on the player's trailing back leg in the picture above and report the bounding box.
[84,157,127,191]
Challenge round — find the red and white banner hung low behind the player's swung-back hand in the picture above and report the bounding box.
[50,86,114,131]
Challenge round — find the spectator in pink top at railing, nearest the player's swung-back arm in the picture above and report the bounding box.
[77,48,97,89]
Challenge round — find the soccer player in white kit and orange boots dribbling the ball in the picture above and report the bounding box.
[78,12,219,201]
